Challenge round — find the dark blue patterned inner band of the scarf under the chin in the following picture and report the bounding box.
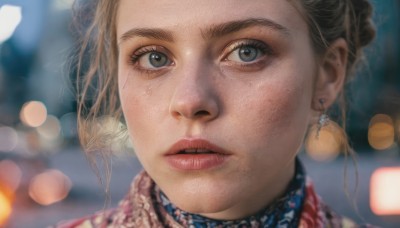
[155,160,306,228]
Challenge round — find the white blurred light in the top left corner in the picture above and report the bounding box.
[0,5,22,43]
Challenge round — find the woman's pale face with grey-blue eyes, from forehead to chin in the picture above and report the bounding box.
[117,0,317,219]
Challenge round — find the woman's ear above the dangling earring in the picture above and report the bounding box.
[312,38,348,111]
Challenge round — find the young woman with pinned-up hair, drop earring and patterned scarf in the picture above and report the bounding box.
[60,0,374,227]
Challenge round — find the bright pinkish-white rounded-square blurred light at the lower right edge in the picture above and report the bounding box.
[370,167,400,215]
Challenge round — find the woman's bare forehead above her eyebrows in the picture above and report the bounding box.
[117,0,307,37]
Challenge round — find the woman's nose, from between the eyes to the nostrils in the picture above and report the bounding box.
[170,61,220,121]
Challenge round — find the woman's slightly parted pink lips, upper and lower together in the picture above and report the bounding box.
[165,139,231,171]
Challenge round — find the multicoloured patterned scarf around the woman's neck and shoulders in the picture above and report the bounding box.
[55,161,360,228]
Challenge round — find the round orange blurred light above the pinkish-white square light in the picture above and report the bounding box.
[368,114,395,150]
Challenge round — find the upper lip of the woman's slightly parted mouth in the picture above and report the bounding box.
[165,138,231,155]
